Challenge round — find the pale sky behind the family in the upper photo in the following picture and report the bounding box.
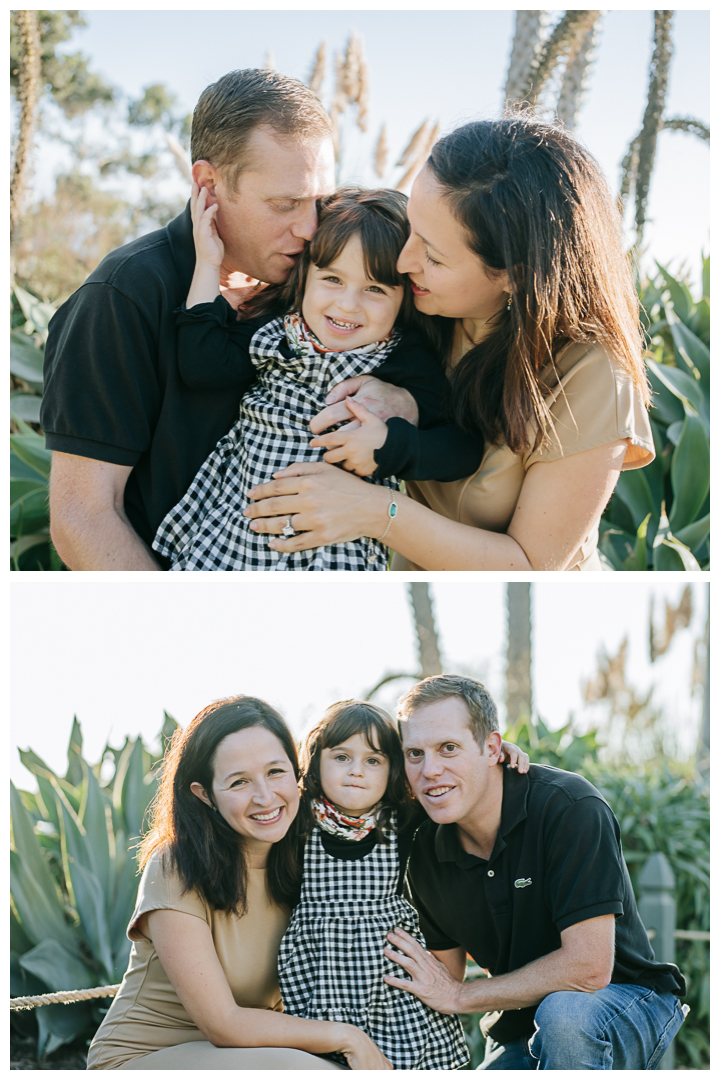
[36,3,710,280]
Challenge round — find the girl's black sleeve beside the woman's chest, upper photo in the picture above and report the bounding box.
[372,334,484,483]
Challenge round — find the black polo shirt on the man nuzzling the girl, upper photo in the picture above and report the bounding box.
[40,204,240,565]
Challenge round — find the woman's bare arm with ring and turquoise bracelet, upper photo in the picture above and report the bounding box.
[245,440,627,571]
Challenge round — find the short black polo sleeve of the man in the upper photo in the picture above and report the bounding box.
[40,282,161,467]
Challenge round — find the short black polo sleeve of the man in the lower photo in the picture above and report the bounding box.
[544,796,625,932]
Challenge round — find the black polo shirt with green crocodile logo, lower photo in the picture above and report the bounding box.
[408,765,685,1043]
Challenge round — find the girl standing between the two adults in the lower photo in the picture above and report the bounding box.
[279,701,468,1069]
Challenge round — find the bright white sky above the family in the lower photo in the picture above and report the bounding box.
[10,575,706,787]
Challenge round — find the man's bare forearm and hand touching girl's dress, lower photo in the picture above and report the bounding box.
[383,915,615,1013]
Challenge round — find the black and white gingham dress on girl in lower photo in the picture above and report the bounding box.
[279,828,468,1069]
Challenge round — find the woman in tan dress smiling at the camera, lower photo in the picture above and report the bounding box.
[87,697,391,1070]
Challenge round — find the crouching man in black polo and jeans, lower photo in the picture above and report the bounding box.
[385,675,685,1069]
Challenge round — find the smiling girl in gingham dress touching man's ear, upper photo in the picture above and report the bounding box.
[153,188,481,570]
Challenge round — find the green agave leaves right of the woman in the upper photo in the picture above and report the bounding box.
[600,257,710,570]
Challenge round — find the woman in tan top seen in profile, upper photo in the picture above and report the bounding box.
[246,114,654,571]
